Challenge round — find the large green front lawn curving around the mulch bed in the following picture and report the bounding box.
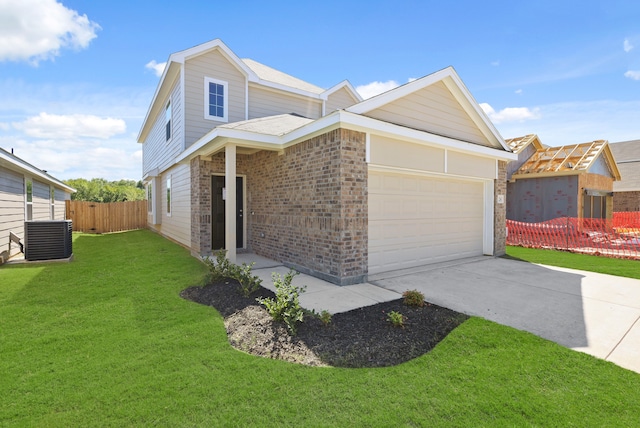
[0,231,640,427]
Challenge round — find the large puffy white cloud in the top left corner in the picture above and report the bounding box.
[0,0,100,65]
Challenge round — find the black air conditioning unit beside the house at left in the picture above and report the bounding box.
[24,220,73,261]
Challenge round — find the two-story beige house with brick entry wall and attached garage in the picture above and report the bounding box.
[138,40,515,285]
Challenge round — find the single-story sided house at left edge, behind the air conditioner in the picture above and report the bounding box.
[0,149,75,261]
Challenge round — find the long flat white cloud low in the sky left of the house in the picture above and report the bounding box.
[13,113,127,139]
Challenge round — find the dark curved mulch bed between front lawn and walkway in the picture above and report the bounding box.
[180,280,468,367]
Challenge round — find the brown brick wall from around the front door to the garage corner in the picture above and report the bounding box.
[191,129,369,285]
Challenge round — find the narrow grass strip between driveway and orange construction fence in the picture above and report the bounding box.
[507,246,640,279]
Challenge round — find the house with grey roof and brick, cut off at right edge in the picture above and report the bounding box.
[610,140,640,211]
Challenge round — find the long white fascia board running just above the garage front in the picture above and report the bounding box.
[332,111,518,161]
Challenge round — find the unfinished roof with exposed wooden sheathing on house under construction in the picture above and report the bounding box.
[512,140,620,181]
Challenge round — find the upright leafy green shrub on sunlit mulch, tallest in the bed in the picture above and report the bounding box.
[256,269,306,335]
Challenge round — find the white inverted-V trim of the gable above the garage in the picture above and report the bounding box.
[346,67,511,152]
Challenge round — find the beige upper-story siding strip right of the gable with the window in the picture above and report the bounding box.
[249,85,322,119]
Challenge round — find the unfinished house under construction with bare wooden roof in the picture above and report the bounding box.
[505,134,620,223]
